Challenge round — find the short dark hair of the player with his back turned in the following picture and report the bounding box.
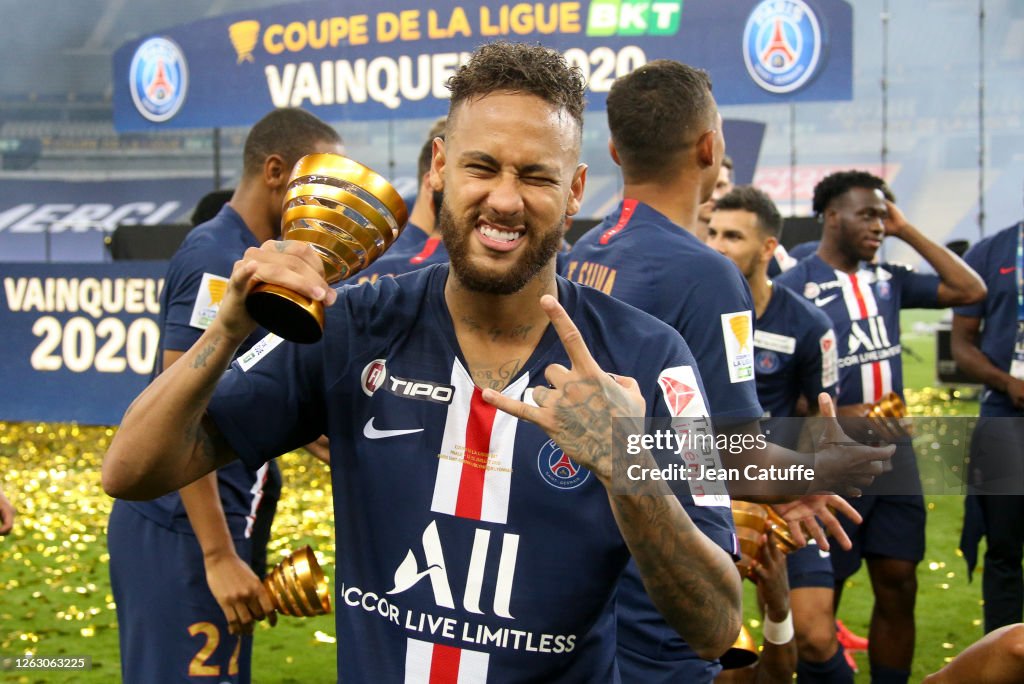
[607,59,718,182]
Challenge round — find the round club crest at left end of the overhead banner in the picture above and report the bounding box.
[128,38,188,123]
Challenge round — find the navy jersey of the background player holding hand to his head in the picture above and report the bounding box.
[775,254,939,405]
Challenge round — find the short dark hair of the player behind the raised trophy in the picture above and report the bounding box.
[242,108,342,176]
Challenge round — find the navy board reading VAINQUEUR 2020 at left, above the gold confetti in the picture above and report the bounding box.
[0,261,167,425]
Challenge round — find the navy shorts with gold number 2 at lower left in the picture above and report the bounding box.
[106,501,253,684]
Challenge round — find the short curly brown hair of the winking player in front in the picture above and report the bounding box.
[447,41,587,141]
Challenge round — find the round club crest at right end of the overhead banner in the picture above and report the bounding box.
[743,0,821,93]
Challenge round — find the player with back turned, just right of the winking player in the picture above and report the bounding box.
[565,59,881,682]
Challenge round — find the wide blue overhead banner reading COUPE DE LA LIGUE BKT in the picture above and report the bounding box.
[114,0,853,131]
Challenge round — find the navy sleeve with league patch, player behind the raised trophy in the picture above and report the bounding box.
[162,237,234,351]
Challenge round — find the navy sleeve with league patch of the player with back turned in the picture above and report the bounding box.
[657,255,763,420]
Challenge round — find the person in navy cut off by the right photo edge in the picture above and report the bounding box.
[952,206,1024,632]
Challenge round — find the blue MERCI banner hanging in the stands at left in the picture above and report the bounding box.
[0,177,213,262]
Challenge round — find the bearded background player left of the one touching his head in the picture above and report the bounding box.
[708,185,853,684]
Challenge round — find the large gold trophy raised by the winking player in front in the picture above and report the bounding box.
[246,154,409,343]
